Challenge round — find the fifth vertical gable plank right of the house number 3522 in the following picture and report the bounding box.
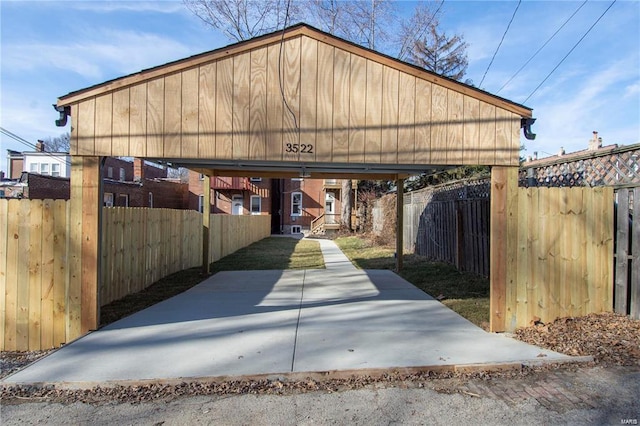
[381,67,399,164]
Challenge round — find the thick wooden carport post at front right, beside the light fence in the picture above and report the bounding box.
[489,166,518,332]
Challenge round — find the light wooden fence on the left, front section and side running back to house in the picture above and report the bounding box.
[0,199,271,351]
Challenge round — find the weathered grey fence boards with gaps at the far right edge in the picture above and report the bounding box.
[614,187,640,319]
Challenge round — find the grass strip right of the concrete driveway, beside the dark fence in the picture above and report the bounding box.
[335,237,489,329]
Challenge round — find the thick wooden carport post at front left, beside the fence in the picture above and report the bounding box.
[67,156,102,341]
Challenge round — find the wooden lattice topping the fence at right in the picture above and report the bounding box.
[520,144,640,186]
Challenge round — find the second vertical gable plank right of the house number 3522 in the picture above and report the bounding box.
[332,49,351,163]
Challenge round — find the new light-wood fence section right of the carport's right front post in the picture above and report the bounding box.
[505,187,613,330]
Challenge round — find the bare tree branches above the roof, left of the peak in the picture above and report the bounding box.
[183,0,301,41]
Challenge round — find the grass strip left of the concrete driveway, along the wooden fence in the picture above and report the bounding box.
[100,237,324,327]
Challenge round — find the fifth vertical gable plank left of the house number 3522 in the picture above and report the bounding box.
[198,62,216,158]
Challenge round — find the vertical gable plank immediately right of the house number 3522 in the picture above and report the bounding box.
[315,43,334,162]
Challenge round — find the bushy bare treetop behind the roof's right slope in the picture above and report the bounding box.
[408,24,469,80]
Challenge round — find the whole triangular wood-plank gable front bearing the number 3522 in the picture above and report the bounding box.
[71,35,521,166]
